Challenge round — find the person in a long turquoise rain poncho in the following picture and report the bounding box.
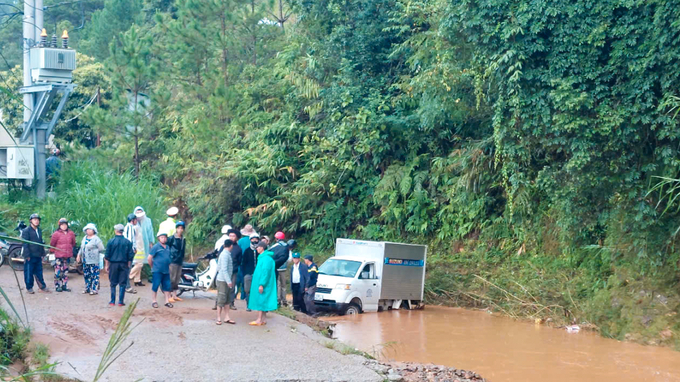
[248,242,277,326]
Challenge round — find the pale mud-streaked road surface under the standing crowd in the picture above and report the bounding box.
[0,266,382,382]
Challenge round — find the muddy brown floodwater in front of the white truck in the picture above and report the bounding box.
[329,306,680,382]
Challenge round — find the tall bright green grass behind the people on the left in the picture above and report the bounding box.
[17,161,165,241]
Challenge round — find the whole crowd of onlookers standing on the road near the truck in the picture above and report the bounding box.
[21,206,318,326]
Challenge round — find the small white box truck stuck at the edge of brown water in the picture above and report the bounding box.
[314,239,427,314]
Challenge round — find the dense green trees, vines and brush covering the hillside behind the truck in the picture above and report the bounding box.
[0,0,680,347]
